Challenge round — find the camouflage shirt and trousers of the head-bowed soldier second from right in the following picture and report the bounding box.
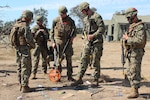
[78,12,105,79]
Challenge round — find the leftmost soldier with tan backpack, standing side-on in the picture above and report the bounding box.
[11,10,35,93]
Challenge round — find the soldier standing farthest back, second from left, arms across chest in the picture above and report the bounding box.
[31,15,49,79]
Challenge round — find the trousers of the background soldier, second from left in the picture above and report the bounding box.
[32,45,47,74]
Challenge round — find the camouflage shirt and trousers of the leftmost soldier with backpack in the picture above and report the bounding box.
[13,20,35,86]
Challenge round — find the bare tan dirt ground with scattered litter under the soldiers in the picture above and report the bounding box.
[0,35,150,100]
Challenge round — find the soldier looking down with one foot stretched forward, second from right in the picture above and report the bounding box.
[71,2,105,86]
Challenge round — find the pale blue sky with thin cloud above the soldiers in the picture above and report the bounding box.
[0,0,150,27]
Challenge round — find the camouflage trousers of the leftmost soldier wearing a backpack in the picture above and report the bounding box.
[16,46,32,86]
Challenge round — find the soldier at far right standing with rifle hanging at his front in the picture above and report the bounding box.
[123,8,146,99]
